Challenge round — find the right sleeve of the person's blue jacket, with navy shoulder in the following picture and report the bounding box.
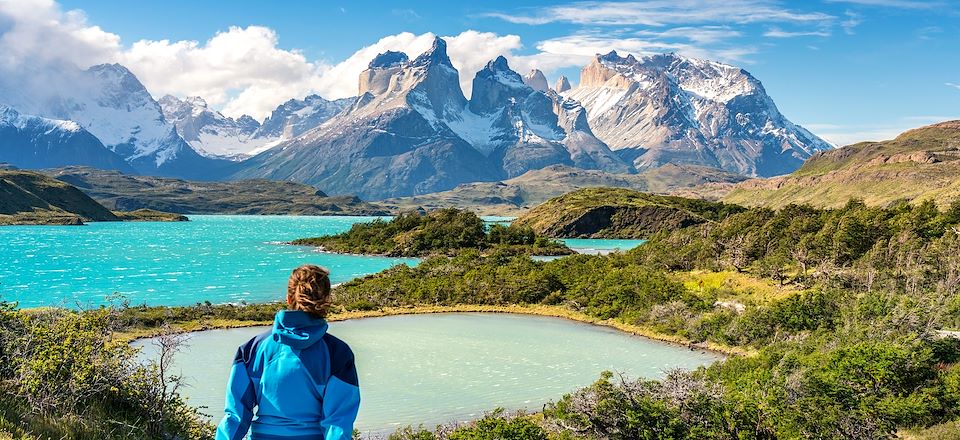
[320,347,360,440]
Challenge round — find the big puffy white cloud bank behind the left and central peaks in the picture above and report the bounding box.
[0,0,536,118]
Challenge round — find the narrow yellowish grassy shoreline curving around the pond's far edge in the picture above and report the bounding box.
[116,304,754,356]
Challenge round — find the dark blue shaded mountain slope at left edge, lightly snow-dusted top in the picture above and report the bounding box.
[0,104,134,173]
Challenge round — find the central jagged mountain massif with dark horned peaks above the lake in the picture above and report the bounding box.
[236,38,632,199]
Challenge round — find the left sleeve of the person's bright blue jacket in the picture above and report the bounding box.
[217,347,256,440]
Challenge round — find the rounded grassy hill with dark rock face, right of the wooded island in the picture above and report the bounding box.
[514,188,742,238]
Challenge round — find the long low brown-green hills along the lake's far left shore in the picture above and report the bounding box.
[46,167,389,215]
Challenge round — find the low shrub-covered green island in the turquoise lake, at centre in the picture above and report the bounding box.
[290,208,573,257]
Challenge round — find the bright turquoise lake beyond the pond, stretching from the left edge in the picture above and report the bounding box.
[0,215,642,308]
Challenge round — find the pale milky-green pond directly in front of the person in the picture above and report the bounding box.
[136,313,722,434]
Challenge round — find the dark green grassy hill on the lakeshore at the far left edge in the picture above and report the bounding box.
[0,169,118,224]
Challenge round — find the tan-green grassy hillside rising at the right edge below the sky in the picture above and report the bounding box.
[723,121,960,208]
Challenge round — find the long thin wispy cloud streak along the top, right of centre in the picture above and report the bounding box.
[487,0,833,26]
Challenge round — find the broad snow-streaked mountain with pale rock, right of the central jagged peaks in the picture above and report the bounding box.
[558,52,831,176]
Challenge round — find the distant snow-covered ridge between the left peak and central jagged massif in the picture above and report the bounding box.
[158,95,265,160]
